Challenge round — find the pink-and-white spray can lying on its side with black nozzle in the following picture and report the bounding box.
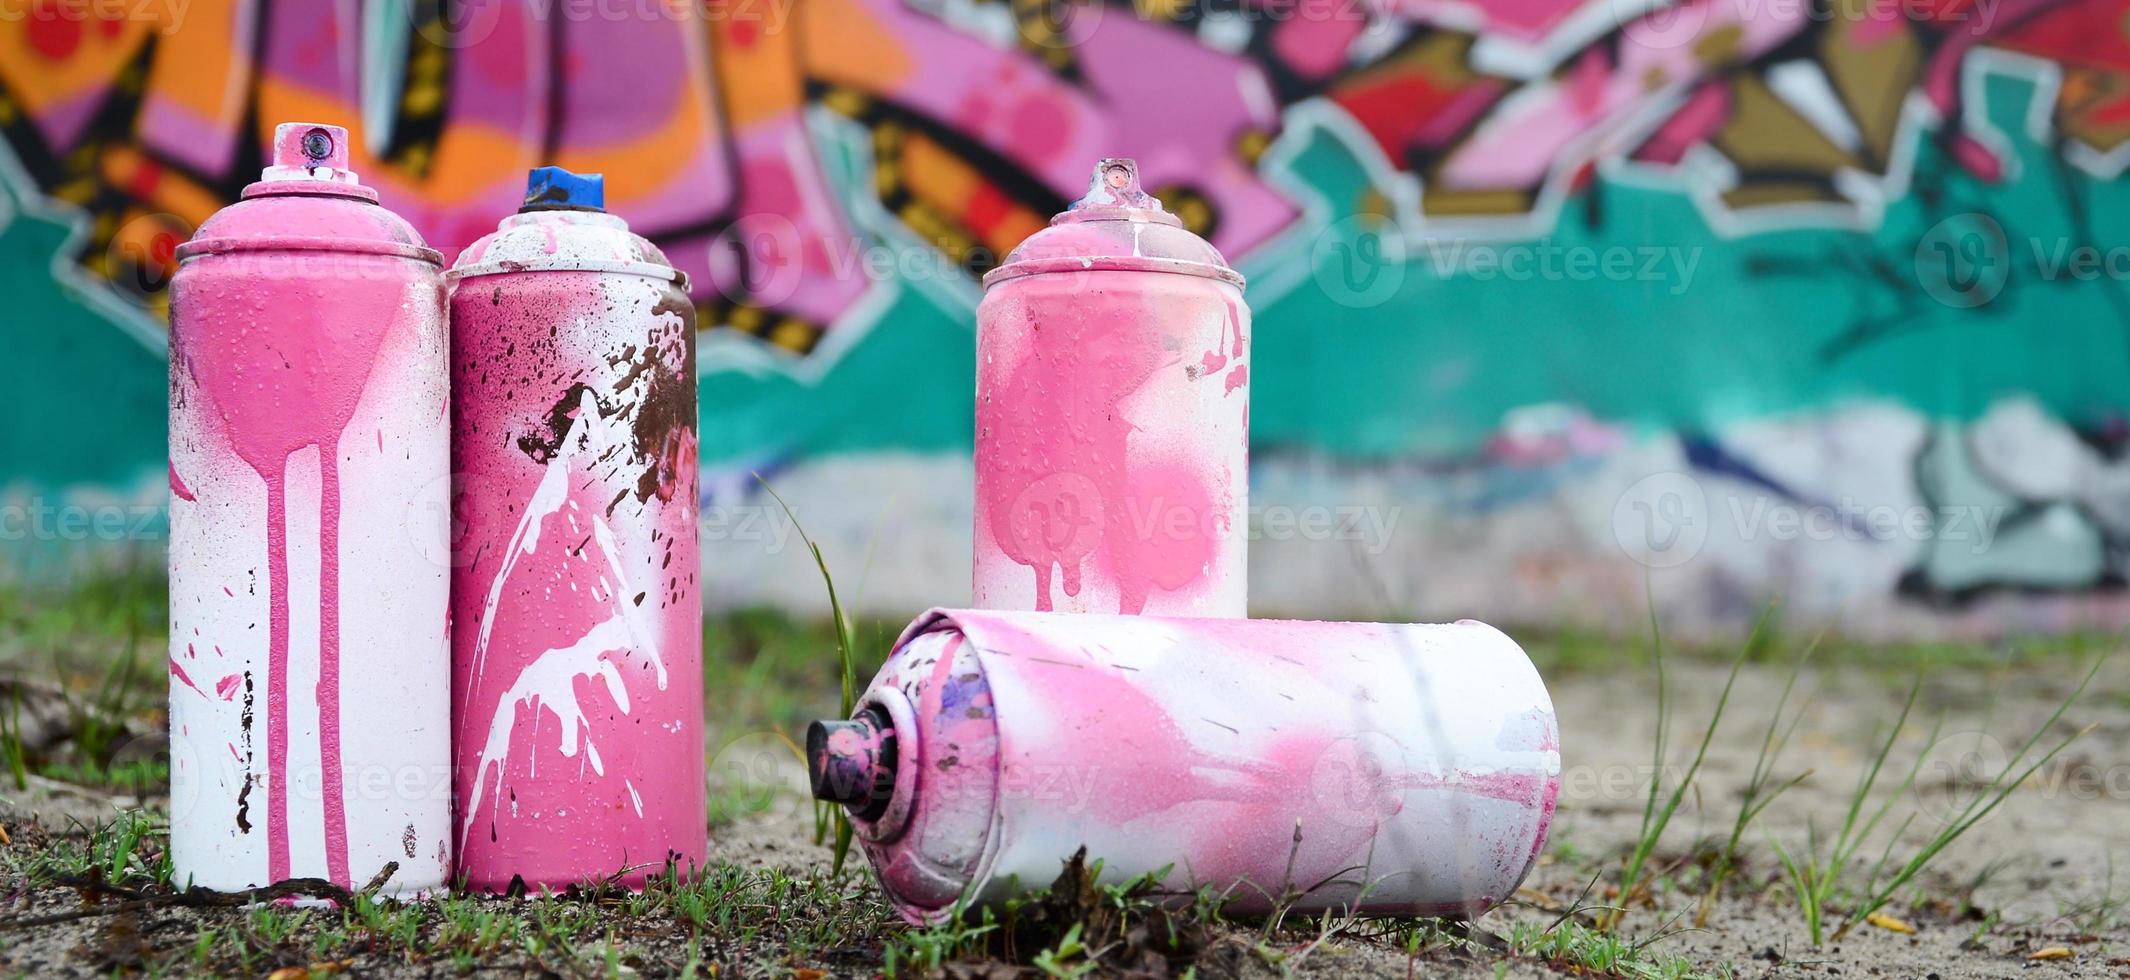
[807,609,1561,922]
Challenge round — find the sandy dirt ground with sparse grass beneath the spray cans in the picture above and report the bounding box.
[0,658,2130,980]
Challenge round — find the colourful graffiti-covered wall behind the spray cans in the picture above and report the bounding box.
[0,0,2130,635]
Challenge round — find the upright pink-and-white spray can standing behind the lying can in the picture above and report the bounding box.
[976,160,1250,616]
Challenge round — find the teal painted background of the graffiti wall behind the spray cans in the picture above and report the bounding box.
[0,67,2130,622]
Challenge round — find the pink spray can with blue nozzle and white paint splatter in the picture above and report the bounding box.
[447,166,709,891]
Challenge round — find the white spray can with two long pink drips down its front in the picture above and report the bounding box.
[170,124,452,895]
